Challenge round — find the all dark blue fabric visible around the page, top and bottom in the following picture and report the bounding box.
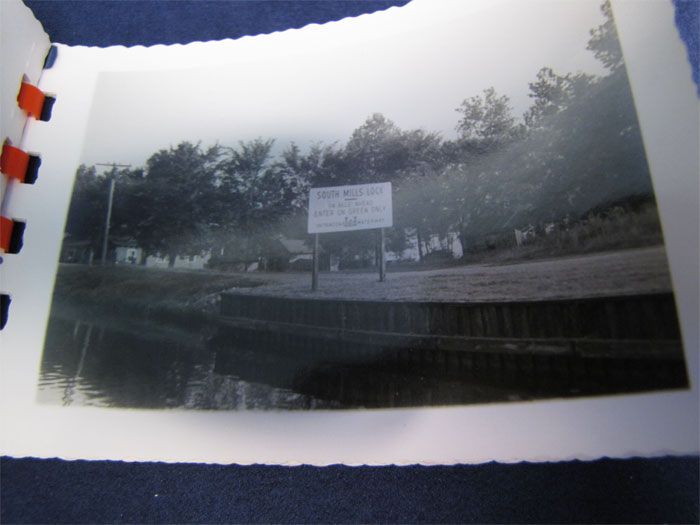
[0,0,700,523]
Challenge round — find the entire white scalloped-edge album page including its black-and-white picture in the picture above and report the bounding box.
[1,0,698,465]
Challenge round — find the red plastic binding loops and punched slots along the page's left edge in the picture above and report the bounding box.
[0,46,57,330]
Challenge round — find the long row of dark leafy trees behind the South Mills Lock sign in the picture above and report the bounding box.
[66,2,653,264]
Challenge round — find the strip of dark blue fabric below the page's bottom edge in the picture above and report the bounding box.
[1,458,699,523]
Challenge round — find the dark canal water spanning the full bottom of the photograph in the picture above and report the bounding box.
[39,316,687,410]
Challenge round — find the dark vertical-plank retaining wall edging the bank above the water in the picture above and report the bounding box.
[221,293,680,341]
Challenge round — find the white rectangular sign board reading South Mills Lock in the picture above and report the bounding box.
[309,182,393,233]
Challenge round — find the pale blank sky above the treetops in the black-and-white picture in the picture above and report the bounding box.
[82,0,604,166]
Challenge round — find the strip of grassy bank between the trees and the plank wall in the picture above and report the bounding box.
[49,246,671,322]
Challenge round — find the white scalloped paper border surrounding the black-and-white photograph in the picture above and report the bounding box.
[0,1,698,465]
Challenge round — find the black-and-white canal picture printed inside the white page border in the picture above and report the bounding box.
[37,0,689,411]
